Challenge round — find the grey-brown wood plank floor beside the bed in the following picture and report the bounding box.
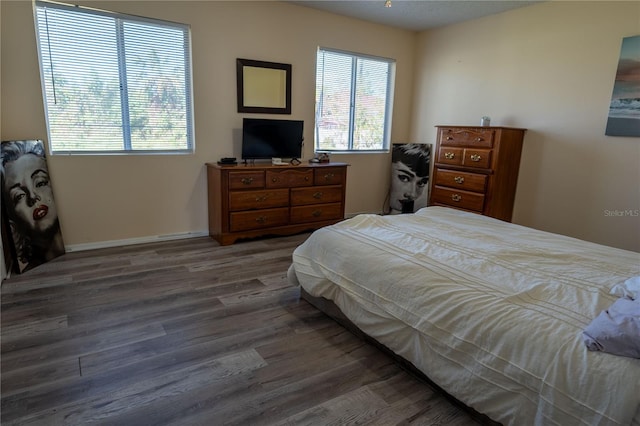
[0,234,478,426]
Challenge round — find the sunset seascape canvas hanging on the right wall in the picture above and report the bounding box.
[605,35,640,136]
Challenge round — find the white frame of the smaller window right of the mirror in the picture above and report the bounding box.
[314,46,396,154]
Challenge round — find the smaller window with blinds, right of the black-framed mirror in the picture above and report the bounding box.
[315,48,395,152]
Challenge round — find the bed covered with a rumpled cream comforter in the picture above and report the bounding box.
[289,206,640,426]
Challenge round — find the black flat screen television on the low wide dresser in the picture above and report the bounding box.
[242,118,304,160]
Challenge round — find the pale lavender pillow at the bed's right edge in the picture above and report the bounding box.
[582,298,640,358]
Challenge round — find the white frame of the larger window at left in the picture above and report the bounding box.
[33,0,195,156]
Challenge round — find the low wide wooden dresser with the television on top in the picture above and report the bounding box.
[207,163,348,245]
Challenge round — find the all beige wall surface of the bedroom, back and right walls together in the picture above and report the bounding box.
[0,0,640,251]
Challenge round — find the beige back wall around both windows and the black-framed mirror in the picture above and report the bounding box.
[0,0,417,249]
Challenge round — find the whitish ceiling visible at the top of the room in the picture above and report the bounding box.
[290,0,541,31]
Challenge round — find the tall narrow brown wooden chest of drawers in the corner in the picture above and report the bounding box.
[429,126,526,222]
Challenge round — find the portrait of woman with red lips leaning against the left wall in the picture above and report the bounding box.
[0,140,65,273]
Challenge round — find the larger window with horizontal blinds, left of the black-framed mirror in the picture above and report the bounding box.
[35,1,193,154]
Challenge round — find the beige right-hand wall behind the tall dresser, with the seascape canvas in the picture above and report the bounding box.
[412,1,640,251]
